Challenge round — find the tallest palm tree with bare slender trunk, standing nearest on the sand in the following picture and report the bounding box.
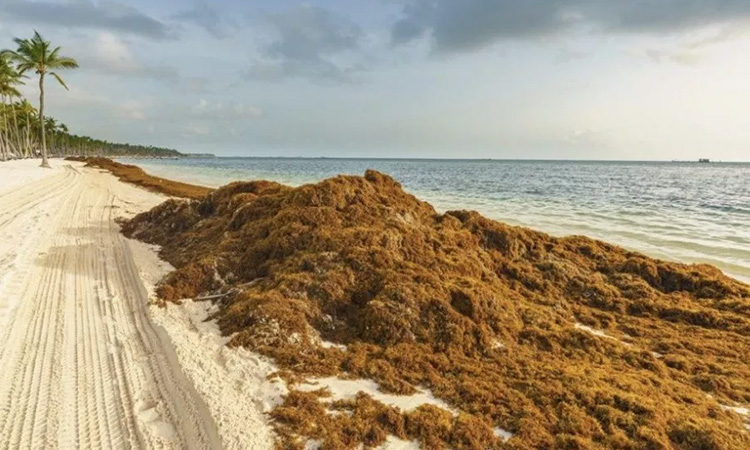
[2,31,78,167]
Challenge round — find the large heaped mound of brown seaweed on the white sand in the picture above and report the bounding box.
[123,171,750,450]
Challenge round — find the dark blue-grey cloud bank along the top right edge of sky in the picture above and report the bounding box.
[392,0,750,52]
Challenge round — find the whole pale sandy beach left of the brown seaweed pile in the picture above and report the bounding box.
[0,161,273,449]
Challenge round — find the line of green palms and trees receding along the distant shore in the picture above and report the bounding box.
[0,31,181,167]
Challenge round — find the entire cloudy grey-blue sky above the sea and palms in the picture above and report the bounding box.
[0,0,750,161]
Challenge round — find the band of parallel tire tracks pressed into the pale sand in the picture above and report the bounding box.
[0,168,221,450]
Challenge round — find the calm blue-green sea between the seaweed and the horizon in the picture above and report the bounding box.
[120,158,750,281]
